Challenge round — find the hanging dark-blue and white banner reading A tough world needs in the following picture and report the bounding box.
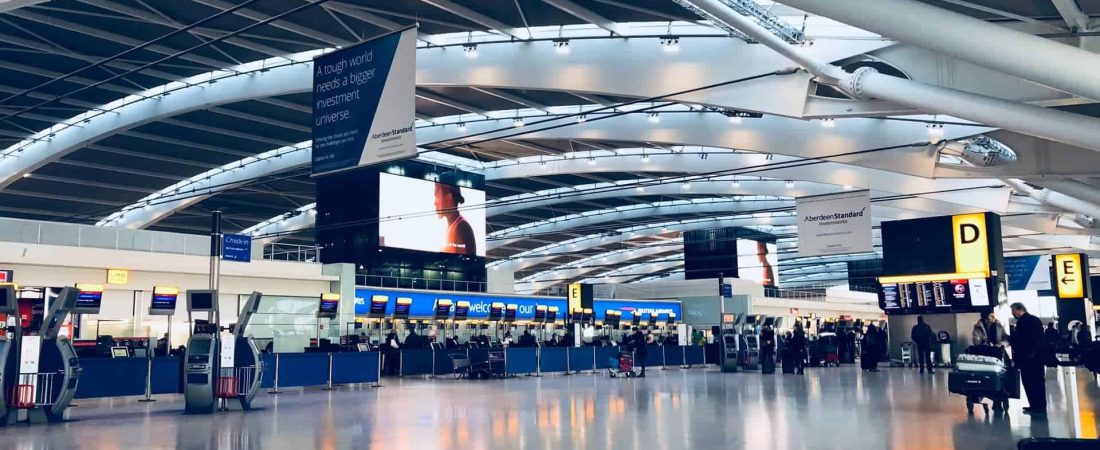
[311,26,417,176]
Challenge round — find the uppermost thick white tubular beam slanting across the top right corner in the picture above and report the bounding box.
[780,0,1100,100]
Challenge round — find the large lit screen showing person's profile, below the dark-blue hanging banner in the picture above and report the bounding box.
[378,174,485,256]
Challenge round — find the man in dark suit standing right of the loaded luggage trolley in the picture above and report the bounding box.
[1011,303,1047,414]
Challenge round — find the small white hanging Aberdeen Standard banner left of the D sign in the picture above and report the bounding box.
[794,190,873,256]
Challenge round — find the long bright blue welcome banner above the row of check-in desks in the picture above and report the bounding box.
[355,287,683,321]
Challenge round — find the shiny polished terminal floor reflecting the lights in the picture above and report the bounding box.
[0,366,1100,450]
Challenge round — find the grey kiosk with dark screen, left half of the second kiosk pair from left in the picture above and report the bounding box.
[184,289,220,414]
